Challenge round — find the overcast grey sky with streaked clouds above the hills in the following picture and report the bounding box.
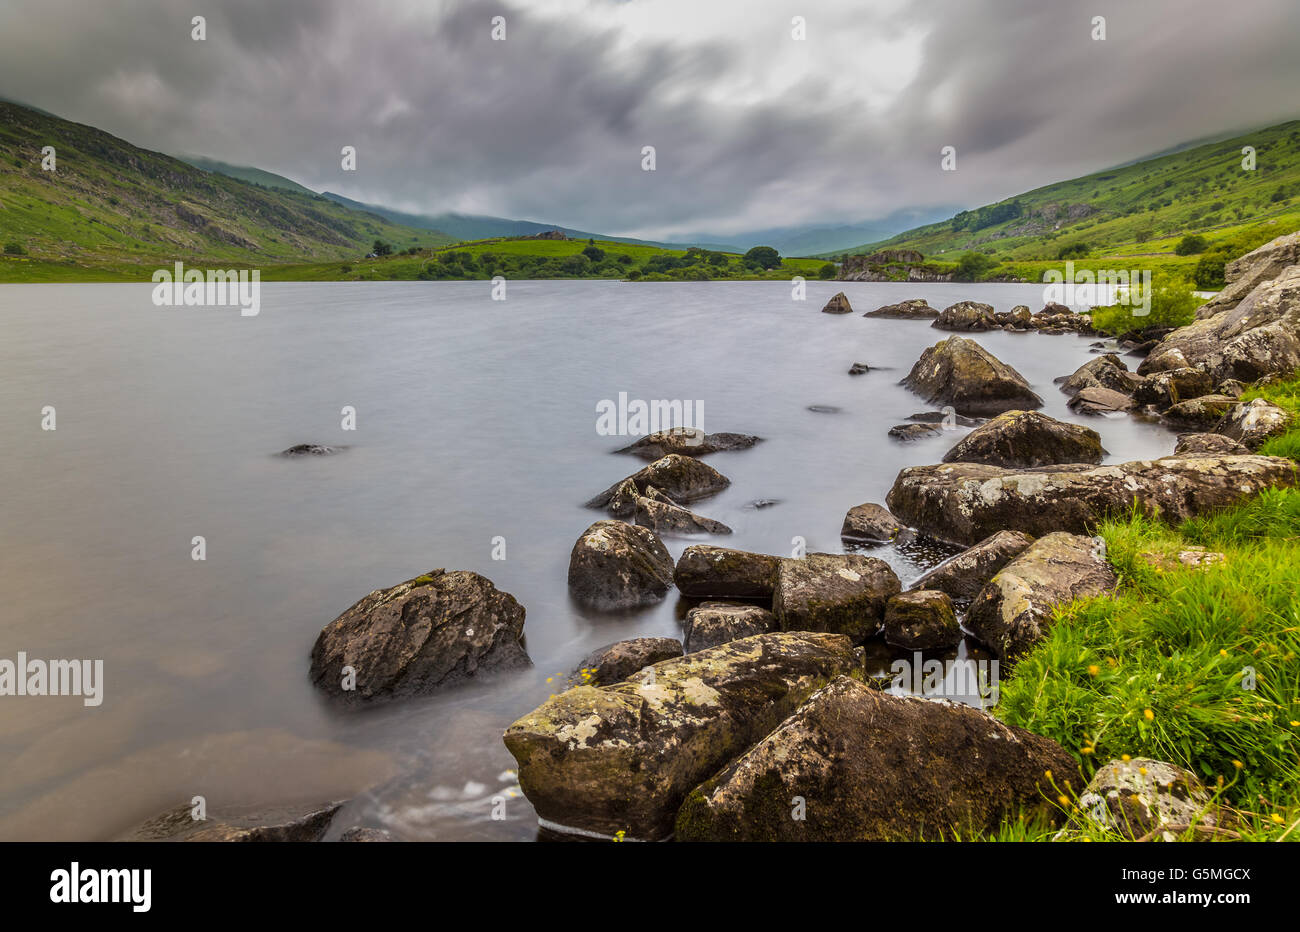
[0,0,1300,238]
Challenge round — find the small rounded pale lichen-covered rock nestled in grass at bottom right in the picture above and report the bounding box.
[1079,758,1218,841]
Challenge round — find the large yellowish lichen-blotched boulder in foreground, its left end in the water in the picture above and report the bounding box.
[504,632,857,838]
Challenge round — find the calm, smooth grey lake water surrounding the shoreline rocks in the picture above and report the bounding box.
[0,282,1173,840]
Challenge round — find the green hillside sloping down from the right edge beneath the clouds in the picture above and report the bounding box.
[832,121,1300,260]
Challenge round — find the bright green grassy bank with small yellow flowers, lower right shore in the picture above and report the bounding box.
[996,380,1300,841]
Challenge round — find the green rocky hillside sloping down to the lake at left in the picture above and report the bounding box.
[0,101,450,269]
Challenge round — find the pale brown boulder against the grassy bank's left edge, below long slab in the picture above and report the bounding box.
[966,533,1118,662]
